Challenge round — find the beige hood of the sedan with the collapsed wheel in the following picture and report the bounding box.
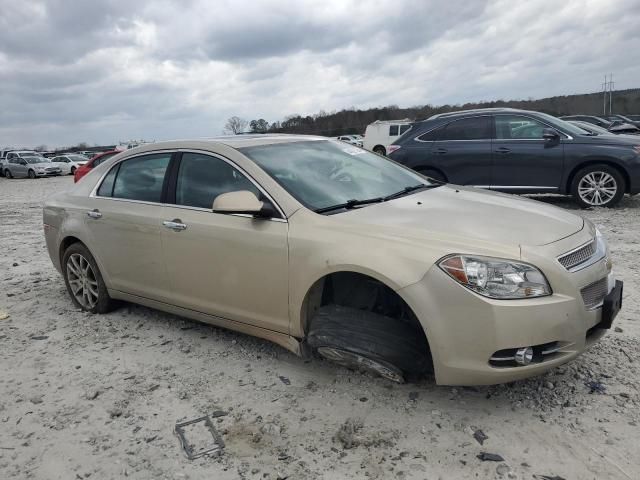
[339,184,584,246]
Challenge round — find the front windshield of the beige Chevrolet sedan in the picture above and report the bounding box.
[239,140,440,210]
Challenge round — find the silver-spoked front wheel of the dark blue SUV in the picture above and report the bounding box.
[571,165,625,208]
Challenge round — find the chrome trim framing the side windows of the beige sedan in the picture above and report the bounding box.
[89,148,288,223]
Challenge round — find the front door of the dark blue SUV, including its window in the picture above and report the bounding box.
[491,114,564,192]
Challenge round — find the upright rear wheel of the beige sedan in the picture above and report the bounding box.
[62,243,114,313]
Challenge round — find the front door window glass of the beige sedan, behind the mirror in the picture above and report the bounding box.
[176,153,262,209]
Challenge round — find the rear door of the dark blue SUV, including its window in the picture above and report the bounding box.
[429,115,492,188]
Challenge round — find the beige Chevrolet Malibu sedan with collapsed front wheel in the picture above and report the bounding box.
[44,135,622,385]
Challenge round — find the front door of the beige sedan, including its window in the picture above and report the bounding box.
[162,152,289,333]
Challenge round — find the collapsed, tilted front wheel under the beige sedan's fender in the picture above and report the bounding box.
[307,305,431,383]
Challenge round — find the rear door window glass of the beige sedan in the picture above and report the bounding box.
[98,153,171,203]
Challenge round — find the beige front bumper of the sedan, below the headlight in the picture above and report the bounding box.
[399,231,615,385]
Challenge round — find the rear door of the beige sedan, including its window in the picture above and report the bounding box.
[84,153,171,302]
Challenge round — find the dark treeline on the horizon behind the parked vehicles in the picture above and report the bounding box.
[241,88,640,137]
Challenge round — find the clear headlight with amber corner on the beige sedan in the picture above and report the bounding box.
[438,255,551,299]
